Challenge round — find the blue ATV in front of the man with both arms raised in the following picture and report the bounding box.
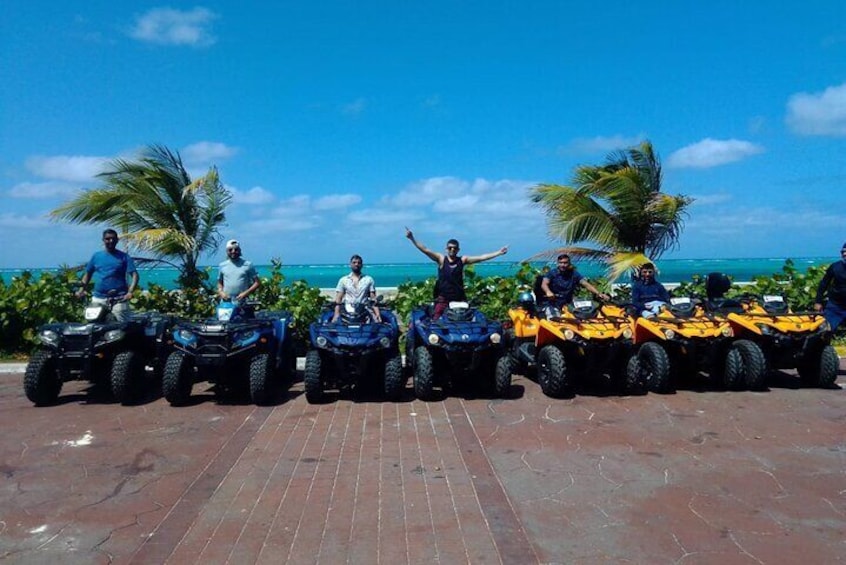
[405,302,512,400]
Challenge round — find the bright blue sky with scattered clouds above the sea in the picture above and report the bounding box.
[0,0,846,268]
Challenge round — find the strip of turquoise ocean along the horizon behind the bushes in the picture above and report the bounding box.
[0,257,837,289]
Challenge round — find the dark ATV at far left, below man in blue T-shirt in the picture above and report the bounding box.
[24,290,172,406]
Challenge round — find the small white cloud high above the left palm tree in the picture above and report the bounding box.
[129,7,217,47]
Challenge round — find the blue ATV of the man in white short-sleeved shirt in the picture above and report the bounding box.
[303,301,406,403]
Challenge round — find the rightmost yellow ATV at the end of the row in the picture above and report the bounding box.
[705,273,840,388]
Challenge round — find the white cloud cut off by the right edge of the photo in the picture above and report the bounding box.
[785,83,846,137]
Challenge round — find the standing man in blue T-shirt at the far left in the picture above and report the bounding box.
[77,228,138,322]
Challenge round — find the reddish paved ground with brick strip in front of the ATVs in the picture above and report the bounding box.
[0,362,846,564]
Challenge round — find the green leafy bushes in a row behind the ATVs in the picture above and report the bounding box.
[0,259,846,357]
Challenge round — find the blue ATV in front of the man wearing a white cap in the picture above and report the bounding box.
[162,301,297,406]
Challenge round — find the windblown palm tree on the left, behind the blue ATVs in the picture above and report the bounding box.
[50,145,232,288]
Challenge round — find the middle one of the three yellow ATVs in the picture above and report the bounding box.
[634,297,766,392]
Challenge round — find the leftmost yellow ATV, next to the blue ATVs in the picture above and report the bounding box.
[505,292,652,397]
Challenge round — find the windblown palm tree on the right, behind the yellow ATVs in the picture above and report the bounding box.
[531,141,693,280]
